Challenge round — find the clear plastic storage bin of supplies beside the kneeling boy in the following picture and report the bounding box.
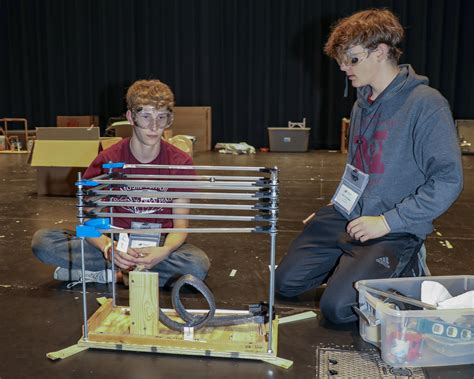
[355,275,474,367]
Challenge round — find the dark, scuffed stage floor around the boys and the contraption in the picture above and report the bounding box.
[0,151,474,379]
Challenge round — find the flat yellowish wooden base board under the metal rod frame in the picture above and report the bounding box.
[78,299,278,361]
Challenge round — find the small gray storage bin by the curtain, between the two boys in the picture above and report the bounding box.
[268,128,311,152]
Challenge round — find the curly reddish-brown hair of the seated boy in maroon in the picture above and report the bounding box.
[127,80,174,111]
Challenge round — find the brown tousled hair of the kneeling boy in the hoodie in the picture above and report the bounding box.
[324,9,404,63]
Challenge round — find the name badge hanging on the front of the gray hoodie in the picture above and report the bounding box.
[331,164,369,215]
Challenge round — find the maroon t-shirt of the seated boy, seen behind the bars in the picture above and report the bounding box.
[83,138,196,229]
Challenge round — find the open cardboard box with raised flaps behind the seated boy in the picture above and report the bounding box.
[29,127,121,196]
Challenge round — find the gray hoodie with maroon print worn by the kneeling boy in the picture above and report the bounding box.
[340,65,463,239]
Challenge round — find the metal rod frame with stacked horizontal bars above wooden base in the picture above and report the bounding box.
[77,164,278,354]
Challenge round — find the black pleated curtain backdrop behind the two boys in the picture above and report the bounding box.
[0,0,474,149]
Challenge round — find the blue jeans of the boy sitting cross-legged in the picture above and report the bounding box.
[31,229,210,287]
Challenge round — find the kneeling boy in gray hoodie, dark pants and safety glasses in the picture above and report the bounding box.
[276,9,463,323]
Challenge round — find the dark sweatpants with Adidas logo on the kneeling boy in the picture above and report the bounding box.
[275,206,423,324]
